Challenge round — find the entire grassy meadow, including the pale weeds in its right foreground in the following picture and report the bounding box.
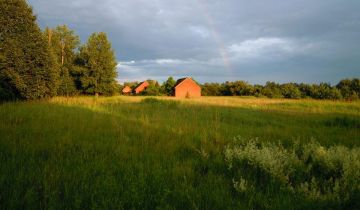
[0,96,360,209]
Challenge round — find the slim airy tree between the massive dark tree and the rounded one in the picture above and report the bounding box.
[44,25,80,95]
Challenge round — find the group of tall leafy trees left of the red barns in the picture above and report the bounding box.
[0,0,119,101]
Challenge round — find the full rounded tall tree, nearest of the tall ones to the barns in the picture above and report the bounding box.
[78,32,117,95]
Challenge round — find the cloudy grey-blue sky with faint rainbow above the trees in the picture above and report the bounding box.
[28,0,360,84]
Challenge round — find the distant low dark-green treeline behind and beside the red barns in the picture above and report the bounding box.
[123,77,360,100]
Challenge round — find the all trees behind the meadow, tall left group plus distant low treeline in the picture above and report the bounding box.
[0,0,360,101]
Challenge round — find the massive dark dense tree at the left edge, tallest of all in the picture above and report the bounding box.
[0,0,57,100]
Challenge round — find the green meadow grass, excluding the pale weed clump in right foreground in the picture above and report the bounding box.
[0,97,360,209]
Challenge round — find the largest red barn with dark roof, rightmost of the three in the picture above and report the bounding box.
[175,77,201,97]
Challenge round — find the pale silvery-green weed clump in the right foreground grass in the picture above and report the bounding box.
[225,138,360,209]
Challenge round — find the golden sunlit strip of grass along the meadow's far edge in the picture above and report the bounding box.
[50,96,360,115]
